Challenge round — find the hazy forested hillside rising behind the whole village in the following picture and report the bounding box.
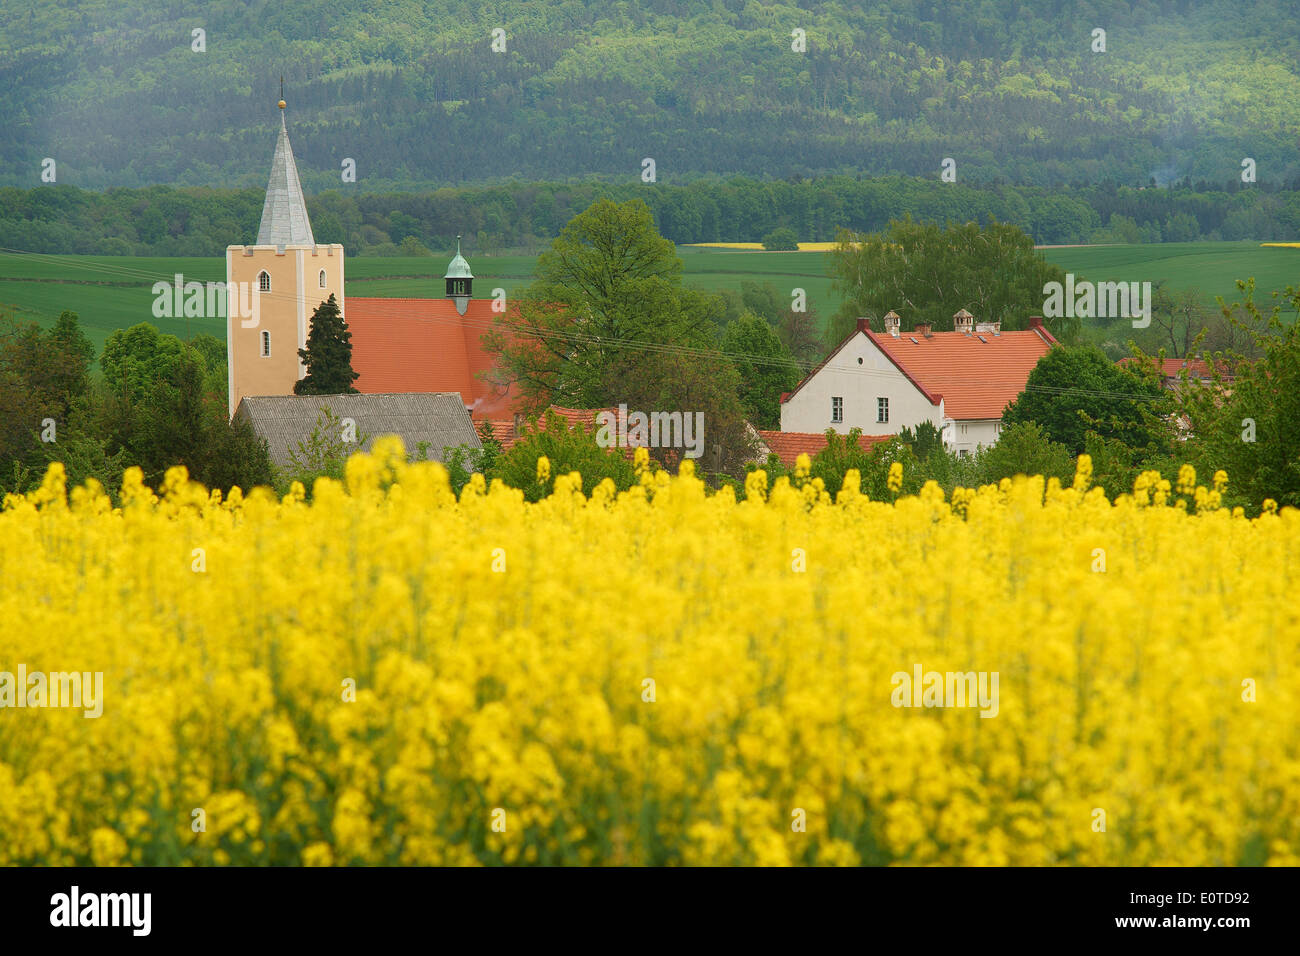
[0,0,1300,193]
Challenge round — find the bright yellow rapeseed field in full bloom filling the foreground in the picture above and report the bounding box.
[0,440,1300,865]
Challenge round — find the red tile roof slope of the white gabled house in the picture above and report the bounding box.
[863,326,1056,420]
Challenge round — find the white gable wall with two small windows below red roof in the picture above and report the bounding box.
[781,332,944,434]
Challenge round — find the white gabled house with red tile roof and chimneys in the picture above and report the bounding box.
[781,310,1057,454]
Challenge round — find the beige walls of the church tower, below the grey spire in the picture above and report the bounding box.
[226,243,346,418]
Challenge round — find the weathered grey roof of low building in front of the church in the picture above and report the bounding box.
[235,392,482,467]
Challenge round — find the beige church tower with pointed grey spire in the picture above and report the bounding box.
[226,94,347,418]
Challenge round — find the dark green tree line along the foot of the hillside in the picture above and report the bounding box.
[0,176,1300,256]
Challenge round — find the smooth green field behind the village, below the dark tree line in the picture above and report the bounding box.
[0,242,1300,356]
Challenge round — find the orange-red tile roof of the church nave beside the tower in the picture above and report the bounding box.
[343,295,521,418]
